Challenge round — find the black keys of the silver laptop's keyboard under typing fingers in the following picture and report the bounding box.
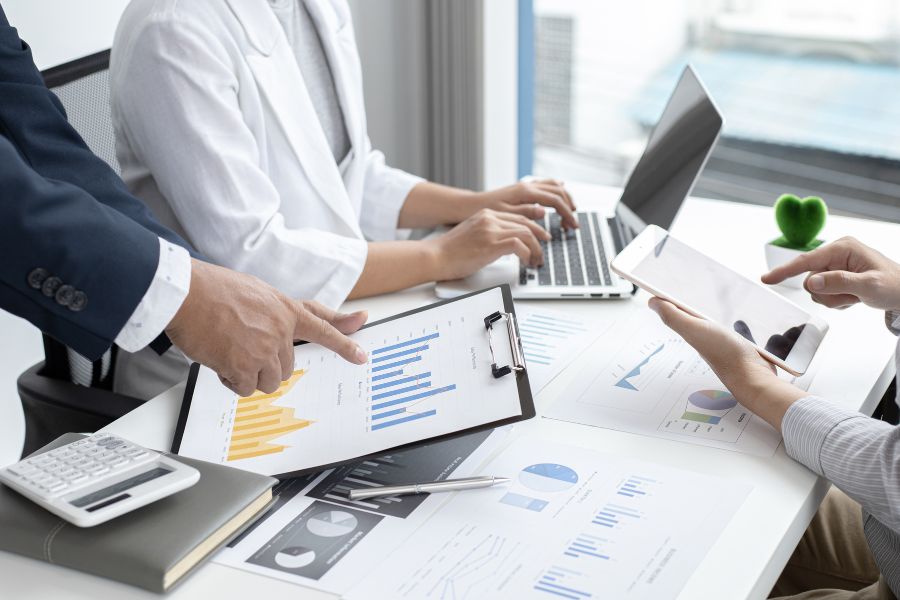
[519,212,612,286]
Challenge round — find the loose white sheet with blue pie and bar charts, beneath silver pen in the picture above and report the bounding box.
[345,437,750,600]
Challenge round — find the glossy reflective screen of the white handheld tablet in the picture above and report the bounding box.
[631,232,821,360]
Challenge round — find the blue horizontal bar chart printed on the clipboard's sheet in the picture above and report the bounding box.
[369,332,456,431]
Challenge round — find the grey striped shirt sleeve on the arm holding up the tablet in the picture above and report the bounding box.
[782,396,900,532]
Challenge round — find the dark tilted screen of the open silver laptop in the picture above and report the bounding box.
[616,66,722,233]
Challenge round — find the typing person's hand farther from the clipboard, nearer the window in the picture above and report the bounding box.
[463,179,578,228]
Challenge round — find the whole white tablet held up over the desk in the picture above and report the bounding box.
[612,225,828,376]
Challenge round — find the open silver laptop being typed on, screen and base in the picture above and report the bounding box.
[436,65,724,300]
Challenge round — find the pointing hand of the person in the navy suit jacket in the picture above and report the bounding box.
[166,259,368,396]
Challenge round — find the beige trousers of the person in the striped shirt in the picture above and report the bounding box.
[770,487,896,600]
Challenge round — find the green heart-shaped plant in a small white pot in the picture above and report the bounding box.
[766,194,828,288]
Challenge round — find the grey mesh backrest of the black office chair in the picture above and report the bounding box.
[41,50,121,387]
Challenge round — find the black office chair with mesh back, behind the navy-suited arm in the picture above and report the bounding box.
[17,50,141,456]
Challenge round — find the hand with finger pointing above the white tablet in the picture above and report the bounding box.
[762,237,900,310]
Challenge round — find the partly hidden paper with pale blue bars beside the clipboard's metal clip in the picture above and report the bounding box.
[516,302,613,393]
